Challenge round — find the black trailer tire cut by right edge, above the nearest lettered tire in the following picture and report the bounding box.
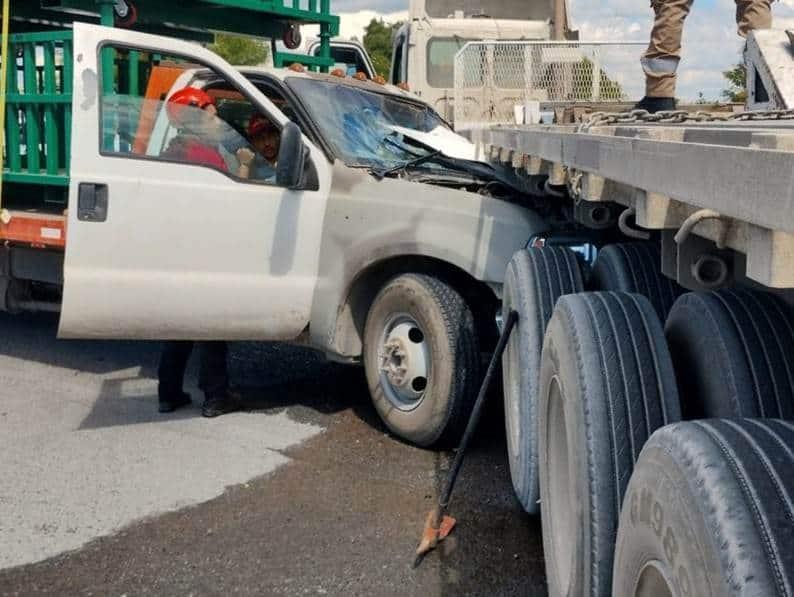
[665,288,794,419]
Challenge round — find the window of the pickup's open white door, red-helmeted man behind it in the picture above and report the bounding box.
[99,47,280,183]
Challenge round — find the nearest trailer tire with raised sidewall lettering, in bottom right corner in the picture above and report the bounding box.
[613,419,794,597]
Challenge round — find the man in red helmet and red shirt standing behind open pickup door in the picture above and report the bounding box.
[157,87,242,417]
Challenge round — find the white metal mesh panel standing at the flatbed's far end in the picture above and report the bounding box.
[454,41,645,127]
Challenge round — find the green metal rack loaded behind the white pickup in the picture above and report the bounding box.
[2,0,339,189]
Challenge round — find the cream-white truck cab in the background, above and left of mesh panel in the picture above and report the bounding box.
[390,0,576,122]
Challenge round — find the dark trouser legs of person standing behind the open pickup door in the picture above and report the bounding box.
[157,340,229,400]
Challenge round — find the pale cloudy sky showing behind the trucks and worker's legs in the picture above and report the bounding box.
[331,0,794,99]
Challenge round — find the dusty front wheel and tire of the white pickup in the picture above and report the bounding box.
[364,274,480,447]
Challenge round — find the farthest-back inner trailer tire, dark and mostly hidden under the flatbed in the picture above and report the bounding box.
[591,242,684,321]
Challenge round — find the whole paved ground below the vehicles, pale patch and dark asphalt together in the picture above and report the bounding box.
[0,315,545,597]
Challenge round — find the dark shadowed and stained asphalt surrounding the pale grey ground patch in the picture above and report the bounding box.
[0,316,545,597]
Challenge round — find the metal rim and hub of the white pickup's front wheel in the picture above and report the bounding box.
[378,314,430,410]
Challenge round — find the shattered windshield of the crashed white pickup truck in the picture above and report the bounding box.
[287,77,449,169]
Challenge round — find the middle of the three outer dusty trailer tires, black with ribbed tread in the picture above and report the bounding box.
[538,292,680,597]
